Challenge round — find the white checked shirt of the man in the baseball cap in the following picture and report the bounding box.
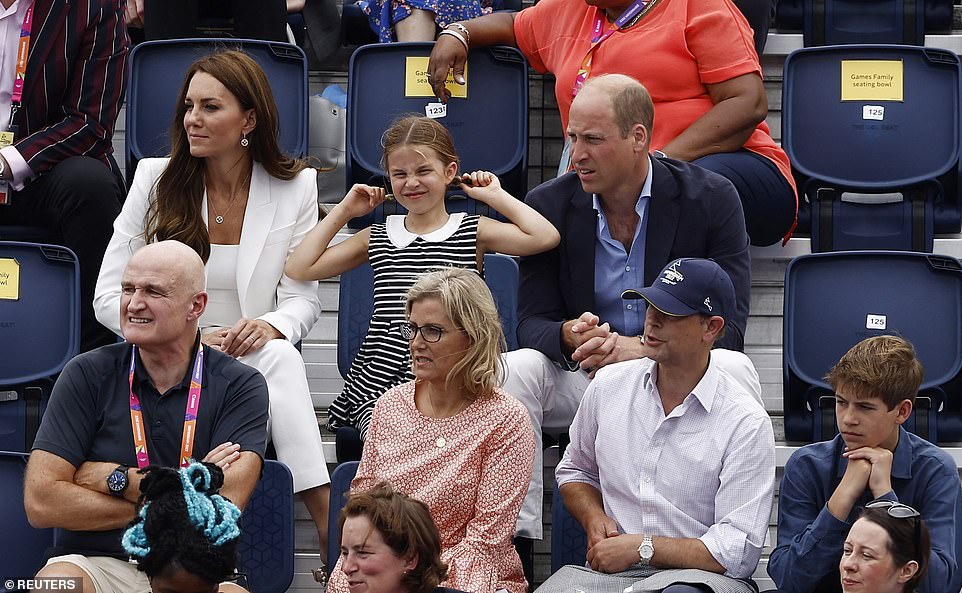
[555,358,775,578]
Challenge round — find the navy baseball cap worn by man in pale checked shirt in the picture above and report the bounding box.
[621,257,735,319]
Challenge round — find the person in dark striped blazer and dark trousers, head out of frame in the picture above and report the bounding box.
[0,0,129,350]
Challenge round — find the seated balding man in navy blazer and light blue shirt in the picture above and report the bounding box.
[504,74,761,539]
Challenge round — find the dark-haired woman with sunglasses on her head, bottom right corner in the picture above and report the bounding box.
[838,500,931,593]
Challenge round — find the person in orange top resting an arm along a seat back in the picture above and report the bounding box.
[428,0,798,245]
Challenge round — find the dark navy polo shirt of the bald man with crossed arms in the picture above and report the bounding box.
[33,344,268,559]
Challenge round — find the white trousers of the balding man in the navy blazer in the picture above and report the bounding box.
[504,348,764,539]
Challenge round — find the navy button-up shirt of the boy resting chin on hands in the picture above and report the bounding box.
[768,428,962,593]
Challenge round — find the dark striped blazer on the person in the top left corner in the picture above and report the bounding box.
[14,0,130,176]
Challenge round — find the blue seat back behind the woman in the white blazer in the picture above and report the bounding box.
[126,39,307,181]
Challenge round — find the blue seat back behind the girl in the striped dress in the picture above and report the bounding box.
[337,253,519,377]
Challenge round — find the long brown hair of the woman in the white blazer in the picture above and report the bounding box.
[144,50,307,262]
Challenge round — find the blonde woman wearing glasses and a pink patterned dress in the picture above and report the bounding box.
[328,268,534,593]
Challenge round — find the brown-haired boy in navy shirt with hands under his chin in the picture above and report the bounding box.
[768,336,962,593]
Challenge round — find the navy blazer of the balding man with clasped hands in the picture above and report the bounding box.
[518,157,751,362]
